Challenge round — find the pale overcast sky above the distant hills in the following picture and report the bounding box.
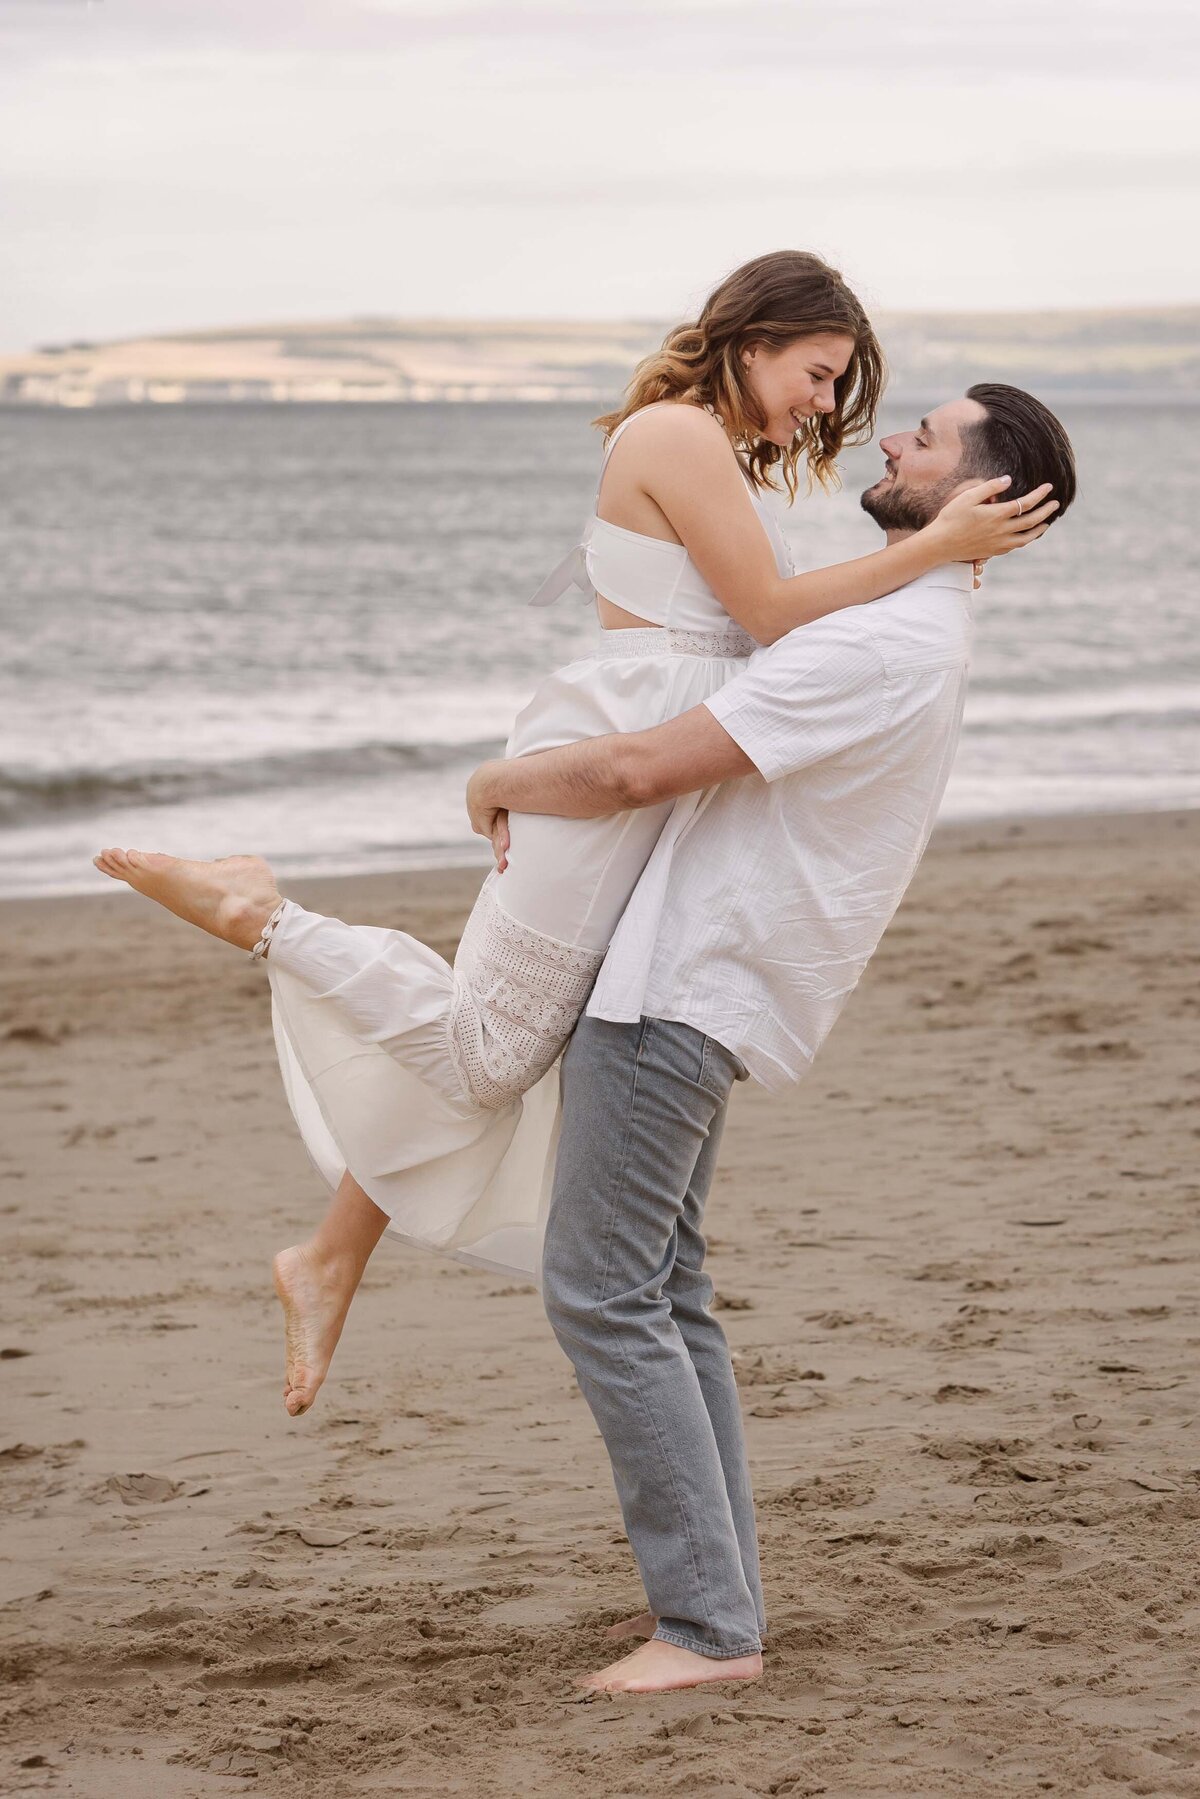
[0,0,1200,351]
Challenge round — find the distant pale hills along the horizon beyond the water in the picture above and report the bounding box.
[0,306,1200,407]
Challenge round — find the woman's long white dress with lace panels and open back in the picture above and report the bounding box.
[266,412,792,1283]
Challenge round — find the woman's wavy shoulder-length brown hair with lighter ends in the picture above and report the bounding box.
[592,250,887,500]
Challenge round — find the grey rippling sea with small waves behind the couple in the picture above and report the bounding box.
[0,394,1200,894]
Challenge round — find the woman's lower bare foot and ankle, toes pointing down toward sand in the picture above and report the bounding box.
[273,1173,389,1418]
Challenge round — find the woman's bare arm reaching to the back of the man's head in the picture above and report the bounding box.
[630,405,1056,644]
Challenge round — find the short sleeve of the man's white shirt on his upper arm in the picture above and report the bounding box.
[703,621,891,781]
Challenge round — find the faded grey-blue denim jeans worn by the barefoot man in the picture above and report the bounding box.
[542,1015,766,1657]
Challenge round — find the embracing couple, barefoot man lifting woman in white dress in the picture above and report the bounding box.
[95,252,1074,1693]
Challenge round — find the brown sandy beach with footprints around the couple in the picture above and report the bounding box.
[0,813,1200,1799]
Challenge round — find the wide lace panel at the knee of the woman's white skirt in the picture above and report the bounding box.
[448,873,604,1112]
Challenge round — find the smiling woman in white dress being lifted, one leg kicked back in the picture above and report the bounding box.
[95,252,1049,1416]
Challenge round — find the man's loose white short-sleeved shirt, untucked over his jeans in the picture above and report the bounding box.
[587,563,973,1088]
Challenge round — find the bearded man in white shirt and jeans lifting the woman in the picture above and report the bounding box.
[468,383,1076,1691]
